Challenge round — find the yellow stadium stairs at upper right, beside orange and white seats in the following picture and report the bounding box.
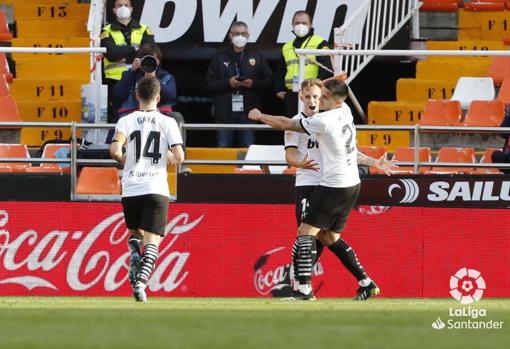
[366,0,510,151]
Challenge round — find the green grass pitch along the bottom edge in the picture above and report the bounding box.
[0,297,510,349]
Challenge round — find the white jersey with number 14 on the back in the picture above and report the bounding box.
[115,111,182,197]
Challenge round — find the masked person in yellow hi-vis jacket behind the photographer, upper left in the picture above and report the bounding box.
[101,0,154,122]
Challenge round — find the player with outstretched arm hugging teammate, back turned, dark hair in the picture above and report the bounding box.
[249,80,394,300]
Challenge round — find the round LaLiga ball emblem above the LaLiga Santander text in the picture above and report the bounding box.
[450,267,486,304]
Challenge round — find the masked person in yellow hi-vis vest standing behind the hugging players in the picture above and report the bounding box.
[275,11,333,118]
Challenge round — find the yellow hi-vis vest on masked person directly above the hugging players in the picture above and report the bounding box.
[282,35,324,90]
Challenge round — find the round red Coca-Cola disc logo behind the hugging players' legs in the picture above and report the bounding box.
[253,247,324,297]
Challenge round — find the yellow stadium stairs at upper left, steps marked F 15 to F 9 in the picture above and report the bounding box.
[0,0,90,147]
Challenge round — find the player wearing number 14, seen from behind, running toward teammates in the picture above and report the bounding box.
[110,77,184,302]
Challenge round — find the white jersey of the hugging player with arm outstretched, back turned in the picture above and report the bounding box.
[300,103,360,188]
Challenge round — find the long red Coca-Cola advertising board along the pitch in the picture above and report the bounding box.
[0,202,510,297]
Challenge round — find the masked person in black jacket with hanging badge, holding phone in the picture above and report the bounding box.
[205,22,273,147]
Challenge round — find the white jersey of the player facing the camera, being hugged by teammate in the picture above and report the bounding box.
[285,113,322,187]
